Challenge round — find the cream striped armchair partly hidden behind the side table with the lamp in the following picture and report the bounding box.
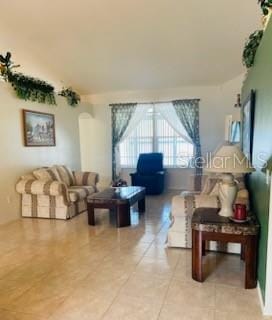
[167,176,249,253]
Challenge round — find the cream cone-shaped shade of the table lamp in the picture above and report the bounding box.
[205,144,255,173]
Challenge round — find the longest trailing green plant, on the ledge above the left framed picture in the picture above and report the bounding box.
[0,52,56,104]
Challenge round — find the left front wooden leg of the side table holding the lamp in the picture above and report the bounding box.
[192,230,204,282]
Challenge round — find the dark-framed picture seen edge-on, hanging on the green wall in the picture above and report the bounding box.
[242,90,255,161]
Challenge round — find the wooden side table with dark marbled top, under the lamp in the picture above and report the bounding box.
[192,208,259,289]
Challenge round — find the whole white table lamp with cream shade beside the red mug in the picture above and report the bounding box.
[205,143,255,217]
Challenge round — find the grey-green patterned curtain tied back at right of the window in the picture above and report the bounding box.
[173,99,203,191]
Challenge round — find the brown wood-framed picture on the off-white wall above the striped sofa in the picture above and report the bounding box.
[23,110,56,147]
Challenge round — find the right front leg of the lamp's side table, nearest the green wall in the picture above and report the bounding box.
[245,236,258,289]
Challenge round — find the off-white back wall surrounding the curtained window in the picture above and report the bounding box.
[83,76,243,189]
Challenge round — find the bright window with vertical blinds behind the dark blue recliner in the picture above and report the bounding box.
[120,108,194,168]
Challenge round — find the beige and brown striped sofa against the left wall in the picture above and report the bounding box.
[16,165,98,219]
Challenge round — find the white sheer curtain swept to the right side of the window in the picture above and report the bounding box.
[154,102,193,143]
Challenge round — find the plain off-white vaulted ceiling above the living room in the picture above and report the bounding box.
[0,0,260,94]
